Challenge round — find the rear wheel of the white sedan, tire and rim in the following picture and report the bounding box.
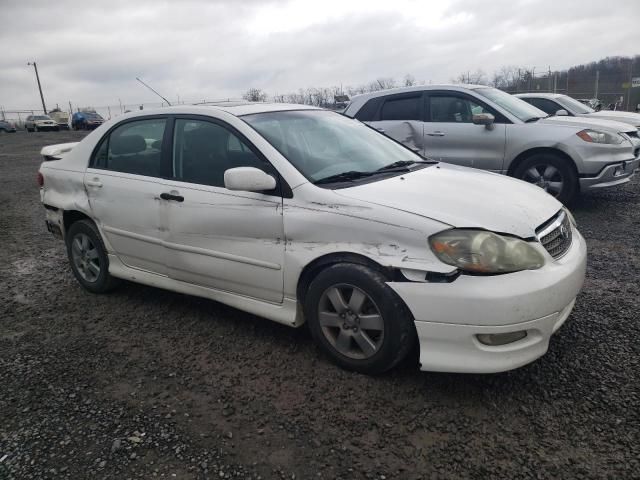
[66,220,119,293]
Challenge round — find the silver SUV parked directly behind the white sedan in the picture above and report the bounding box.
[344,85,640,203]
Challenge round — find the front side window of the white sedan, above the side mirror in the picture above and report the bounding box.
[173,119,272,187]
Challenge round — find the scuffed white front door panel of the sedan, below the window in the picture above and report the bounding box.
[165,182,284,302]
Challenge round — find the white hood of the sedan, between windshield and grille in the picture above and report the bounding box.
[335,163,562,238]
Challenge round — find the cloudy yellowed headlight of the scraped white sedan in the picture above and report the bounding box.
[429,229,544,273]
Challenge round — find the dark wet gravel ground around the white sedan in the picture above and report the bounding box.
[0,132,640,479]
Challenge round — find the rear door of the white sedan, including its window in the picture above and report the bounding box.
[84,116,170,275]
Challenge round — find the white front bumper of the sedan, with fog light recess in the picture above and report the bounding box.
[388,230,587,373]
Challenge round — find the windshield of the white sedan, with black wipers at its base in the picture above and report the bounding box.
[242,110,425,183]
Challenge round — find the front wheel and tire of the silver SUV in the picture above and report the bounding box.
[513,153,579,204]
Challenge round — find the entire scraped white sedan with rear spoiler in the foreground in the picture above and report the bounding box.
[39,103,586,373]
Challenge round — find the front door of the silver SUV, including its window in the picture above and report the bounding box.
[424,91,508,171]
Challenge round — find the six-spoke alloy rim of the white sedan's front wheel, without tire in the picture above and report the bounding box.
[318,284,384,360]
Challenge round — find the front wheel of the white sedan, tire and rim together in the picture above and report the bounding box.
[304,263,416,374]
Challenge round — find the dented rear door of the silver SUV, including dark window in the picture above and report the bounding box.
[364,92,425,155]
